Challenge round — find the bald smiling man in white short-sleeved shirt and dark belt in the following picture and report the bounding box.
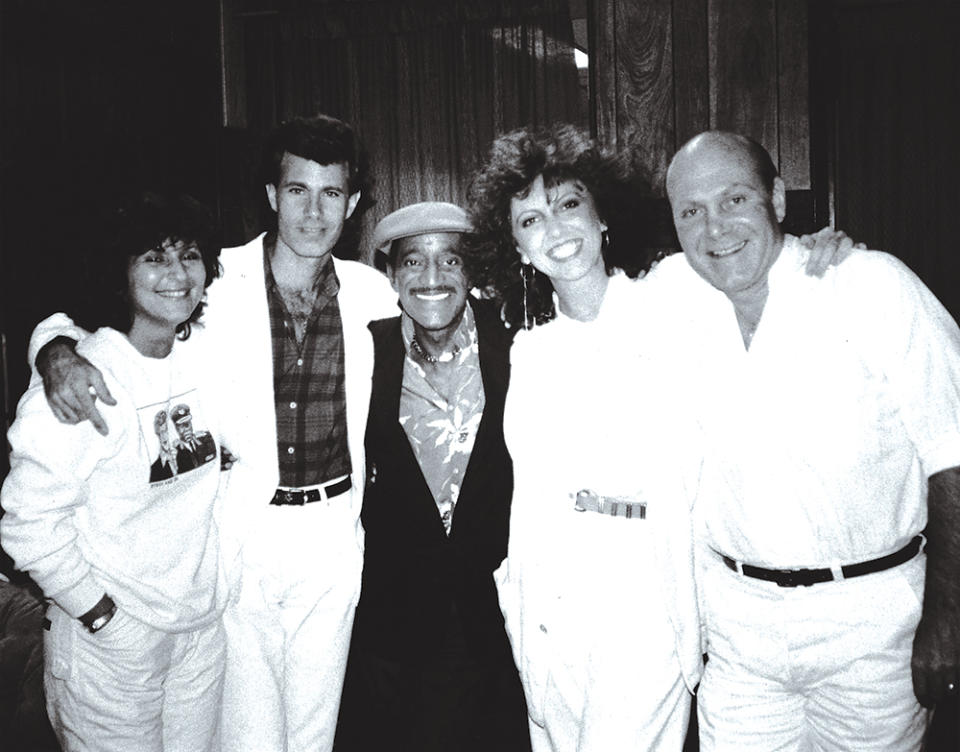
[661,132,960,752]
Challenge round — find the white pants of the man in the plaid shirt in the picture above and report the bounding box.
[222,493,363,752]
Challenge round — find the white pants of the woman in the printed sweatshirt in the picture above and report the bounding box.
[44,605,225,752]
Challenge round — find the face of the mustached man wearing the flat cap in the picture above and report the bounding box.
[389,232,470,335]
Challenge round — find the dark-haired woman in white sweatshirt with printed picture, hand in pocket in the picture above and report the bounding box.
[0,194,226,752]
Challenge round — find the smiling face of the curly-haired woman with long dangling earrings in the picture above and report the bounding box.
[510,175,607,285]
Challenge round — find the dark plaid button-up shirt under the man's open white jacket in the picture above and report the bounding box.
[263,238,351,488]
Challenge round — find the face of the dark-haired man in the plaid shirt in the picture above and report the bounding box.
[267,153,360,259]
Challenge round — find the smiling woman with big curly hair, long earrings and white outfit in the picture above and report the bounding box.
[467,125,700,752]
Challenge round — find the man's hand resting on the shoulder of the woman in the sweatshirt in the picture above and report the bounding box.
[36,337,117,436]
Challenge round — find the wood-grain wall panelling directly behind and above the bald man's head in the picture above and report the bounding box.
[591,0,811,195]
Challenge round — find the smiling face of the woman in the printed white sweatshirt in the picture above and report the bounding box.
[127,240,207,355]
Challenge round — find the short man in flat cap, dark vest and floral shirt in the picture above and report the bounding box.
[336,202,530,752]
